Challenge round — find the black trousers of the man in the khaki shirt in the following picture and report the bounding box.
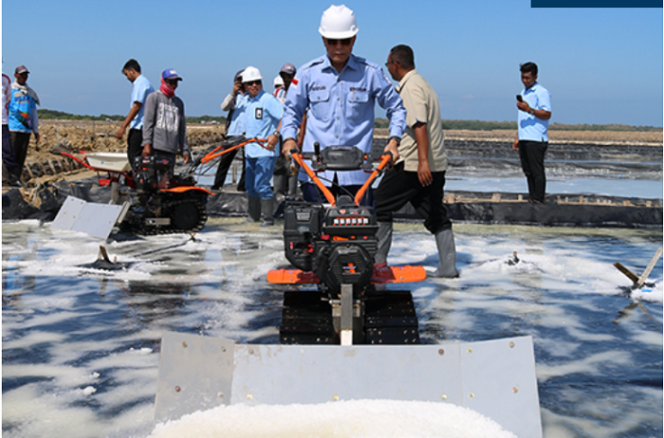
[374,162,452,234]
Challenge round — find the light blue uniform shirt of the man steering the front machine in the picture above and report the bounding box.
[281,54,406,186]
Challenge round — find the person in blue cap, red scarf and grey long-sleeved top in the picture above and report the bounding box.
[141,68,191,176]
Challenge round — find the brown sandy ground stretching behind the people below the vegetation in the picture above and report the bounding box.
[3,120,662,193]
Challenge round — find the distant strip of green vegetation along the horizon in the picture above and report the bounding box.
[39,109,662,132]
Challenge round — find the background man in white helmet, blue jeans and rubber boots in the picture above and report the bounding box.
[238,67,284,226]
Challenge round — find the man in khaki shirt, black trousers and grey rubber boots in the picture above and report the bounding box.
[375,45,459,278]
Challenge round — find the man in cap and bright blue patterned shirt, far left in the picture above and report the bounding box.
[8,65,40,181]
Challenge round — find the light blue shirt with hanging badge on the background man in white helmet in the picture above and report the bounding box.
[235,90,284,158]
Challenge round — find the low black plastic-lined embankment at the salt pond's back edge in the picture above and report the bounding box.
[2,181,662,228]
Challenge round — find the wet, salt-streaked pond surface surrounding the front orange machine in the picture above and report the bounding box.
[2,219,663,438]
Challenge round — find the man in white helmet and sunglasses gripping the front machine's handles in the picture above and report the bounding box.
[281,5,406,205]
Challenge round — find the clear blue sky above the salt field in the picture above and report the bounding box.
[2,0,664,126]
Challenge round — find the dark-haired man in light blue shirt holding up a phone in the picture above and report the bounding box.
[512,62,551,204]
